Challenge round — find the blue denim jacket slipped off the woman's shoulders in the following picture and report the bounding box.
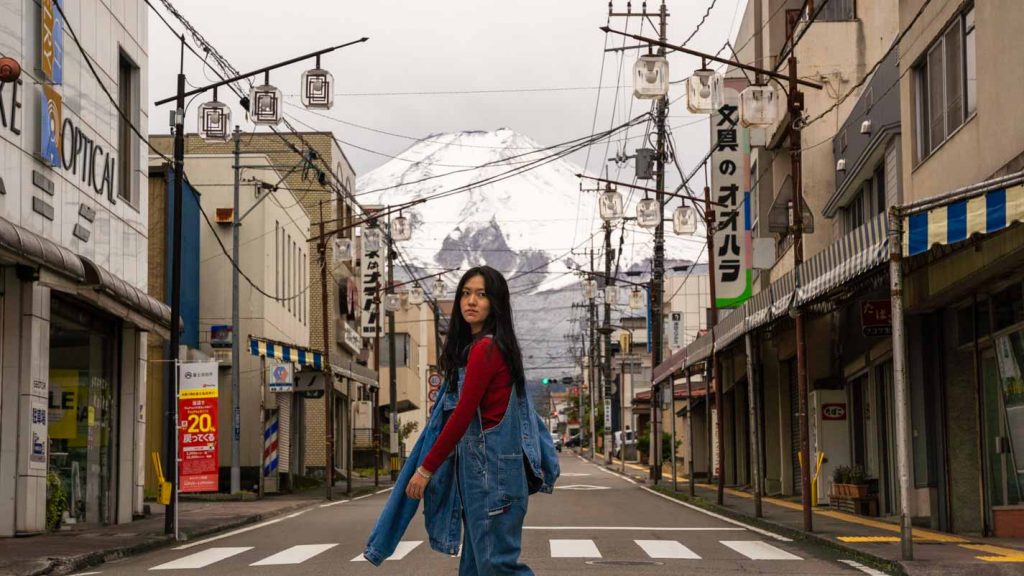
[362,362,560,566]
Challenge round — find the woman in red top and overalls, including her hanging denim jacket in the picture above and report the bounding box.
[362,266,559,576]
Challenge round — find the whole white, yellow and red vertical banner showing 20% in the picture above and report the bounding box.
[178,362,219,492]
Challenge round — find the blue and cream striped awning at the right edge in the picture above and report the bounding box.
[903,173,1024,256]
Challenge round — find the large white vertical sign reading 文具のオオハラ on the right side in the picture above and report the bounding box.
[711,88,752,307]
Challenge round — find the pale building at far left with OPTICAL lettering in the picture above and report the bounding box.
[0,0,170,536]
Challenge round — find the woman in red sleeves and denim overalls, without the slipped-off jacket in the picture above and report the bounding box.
[406,266,534,576]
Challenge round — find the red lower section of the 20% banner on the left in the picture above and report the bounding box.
[178,397,219,492]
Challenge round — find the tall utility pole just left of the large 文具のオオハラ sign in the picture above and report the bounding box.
[650,0,669,485]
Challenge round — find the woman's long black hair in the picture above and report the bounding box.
[438,265,526,396]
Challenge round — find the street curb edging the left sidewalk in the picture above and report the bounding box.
[33,487,380,576]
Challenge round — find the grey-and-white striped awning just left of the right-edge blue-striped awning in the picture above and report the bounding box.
[793,213,889,306]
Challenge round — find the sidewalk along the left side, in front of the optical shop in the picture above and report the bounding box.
[0,478,390,576]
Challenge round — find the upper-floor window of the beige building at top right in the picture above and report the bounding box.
[913,7,977,162]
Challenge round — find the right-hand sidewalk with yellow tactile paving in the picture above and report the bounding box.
[585,453,1024,576]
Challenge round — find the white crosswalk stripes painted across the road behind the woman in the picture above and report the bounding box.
[150,539,803,570]
